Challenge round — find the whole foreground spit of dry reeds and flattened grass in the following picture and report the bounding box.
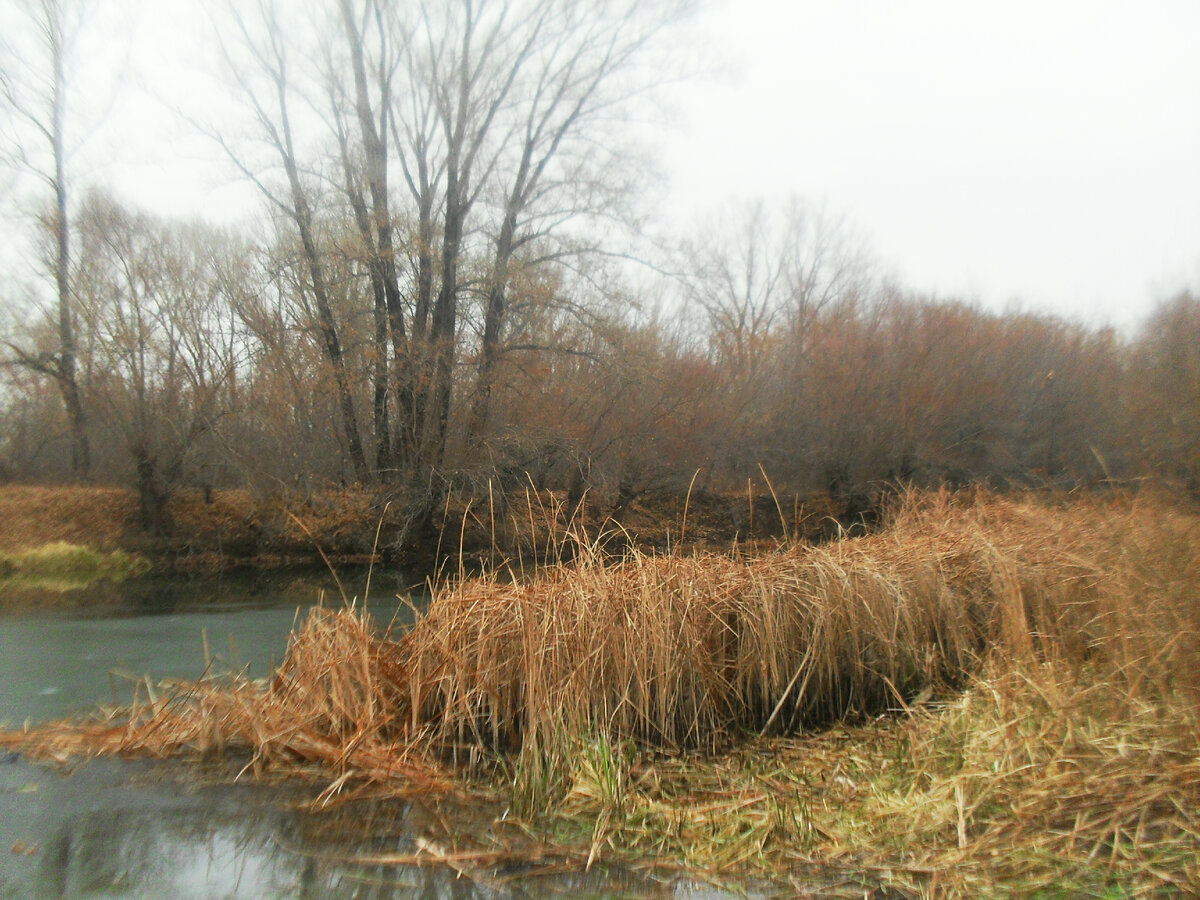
[5,494,1200,896]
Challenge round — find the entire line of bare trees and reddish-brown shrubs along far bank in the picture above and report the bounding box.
[0,0,1200,532]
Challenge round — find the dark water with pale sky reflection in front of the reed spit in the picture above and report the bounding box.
[0,761,758,900]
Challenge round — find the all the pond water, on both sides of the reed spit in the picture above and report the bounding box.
[0,571,782,900]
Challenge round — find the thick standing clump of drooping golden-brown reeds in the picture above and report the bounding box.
[402,494,1200,748]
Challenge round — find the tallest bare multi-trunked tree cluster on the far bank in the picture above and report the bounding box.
[204,0,690,494]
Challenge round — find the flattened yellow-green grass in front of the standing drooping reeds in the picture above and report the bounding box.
[556,666,1200,896]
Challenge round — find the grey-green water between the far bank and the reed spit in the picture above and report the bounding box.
[0,571,422,727]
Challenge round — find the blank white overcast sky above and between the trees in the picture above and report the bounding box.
[9,0,1200,325]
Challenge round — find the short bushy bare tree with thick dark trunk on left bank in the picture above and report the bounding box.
[74,194,245,534]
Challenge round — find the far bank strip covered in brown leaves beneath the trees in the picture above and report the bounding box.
[0,485,876,587]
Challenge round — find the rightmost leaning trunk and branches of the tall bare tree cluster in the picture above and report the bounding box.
[470,2,689,434]
